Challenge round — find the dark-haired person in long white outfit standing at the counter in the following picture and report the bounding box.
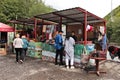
[64,33,75,69]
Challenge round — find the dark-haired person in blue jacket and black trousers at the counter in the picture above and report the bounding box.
[54,31,63,65]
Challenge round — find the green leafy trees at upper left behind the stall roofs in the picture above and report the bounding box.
[0,0,54,23]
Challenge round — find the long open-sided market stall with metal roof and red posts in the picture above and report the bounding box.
[9,7,106,75]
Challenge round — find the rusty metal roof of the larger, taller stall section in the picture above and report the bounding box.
[34,7,105,24]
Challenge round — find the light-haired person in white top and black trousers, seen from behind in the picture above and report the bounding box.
[13,34,24,63]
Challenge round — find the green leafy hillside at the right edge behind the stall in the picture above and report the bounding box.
[105,6,120,43]
